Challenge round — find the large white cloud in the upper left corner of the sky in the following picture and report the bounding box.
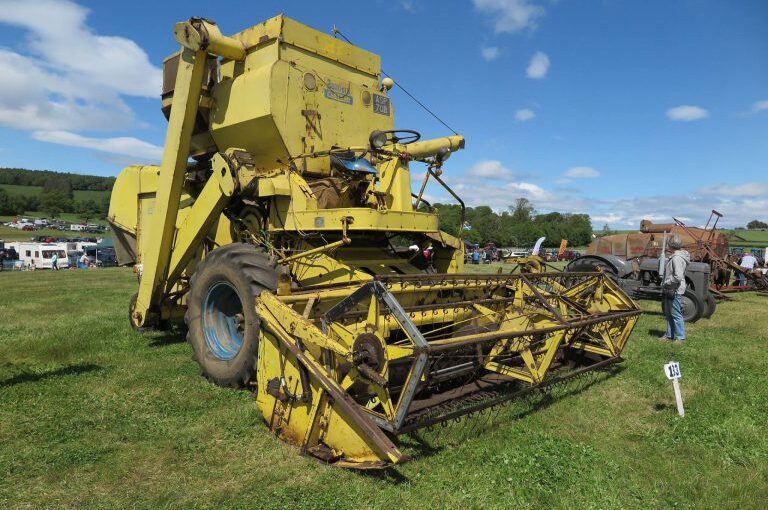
[0,0,162,147]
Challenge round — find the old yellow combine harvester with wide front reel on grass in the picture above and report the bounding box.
[109,16,640,468]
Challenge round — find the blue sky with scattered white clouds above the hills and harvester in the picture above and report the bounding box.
[0,0,768,228]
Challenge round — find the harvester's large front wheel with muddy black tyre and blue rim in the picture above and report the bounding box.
[184,243,278,388]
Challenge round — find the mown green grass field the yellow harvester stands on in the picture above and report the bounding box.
[0,266,768,510]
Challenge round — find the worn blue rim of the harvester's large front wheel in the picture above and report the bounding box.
[202,282,245,361]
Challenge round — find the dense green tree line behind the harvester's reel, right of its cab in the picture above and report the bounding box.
[433,198,592,248]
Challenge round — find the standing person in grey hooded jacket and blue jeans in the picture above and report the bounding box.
[661,234,691,342]
